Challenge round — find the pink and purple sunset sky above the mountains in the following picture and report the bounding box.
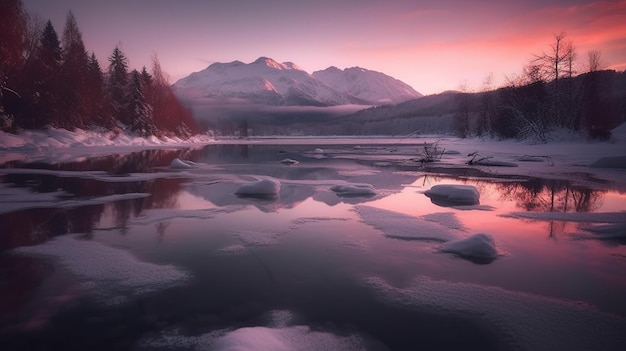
[22,0,626,94]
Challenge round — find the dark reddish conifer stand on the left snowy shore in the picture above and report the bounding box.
[0,0,198,137]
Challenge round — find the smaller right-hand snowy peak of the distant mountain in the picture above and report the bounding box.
[313,66,422,105]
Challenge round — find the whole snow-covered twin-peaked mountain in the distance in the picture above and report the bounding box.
[174,57,421,106]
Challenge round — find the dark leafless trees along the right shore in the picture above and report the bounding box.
[454,33,626,142]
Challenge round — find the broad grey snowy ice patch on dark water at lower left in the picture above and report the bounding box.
[13,235,189,304]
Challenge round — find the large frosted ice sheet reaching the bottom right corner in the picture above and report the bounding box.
[365,277,626,351]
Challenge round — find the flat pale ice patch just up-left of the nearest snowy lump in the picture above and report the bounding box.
[355,206,457,241]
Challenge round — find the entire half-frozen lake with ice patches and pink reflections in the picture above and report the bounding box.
[0,138,626,350]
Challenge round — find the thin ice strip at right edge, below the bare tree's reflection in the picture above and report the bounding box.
[500,212,626,223]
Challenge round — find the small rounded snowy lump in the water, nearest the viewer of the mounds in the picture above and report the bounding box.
[439,233,498,263]
